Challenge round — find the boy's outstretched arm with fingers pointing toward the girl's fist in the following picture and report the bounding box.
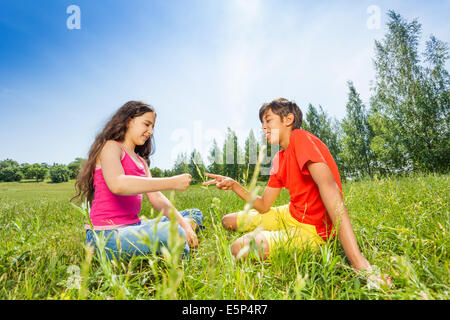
[202,173,281,213]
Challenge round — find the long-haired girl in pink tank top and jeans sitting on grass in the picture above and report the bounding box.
[74,101,203,259]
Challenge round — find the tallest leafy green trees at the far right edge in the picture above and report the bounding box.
[369,11,450,172]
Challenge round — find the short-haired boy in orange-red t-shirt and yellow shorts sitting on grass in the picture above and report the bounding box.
[203,98,390,285]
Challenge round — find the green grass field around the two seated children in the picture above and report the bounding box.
[0,175,450,299]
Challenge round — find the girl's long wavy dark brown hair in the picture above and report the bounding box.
[71,101,156,204]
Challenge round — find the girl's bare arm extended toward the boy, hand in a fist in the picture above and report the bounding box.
[99,141,191,195]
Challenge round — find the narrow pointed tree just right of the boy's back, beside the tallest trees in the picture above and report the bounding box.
[340,81,374,178]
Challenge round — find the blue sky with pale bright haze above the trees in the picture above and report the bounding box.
[0,0,450,169]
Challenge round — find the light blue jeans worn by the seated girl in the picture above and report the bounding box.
[85,209,204,260]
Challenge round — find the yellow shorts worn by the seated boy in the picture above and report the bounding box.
[237,204,325,251]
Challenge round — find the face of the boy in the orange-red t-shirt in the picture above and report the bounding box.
[262,109,294,144]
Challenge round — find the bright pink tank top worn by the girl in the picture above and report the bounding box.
[85,143,147,230]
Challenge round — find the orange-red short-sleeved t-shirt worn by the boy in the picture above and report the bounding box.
[267,129,342,240]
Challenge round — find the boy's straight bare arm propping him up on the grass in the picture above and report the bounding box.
[307,162,371,270]
